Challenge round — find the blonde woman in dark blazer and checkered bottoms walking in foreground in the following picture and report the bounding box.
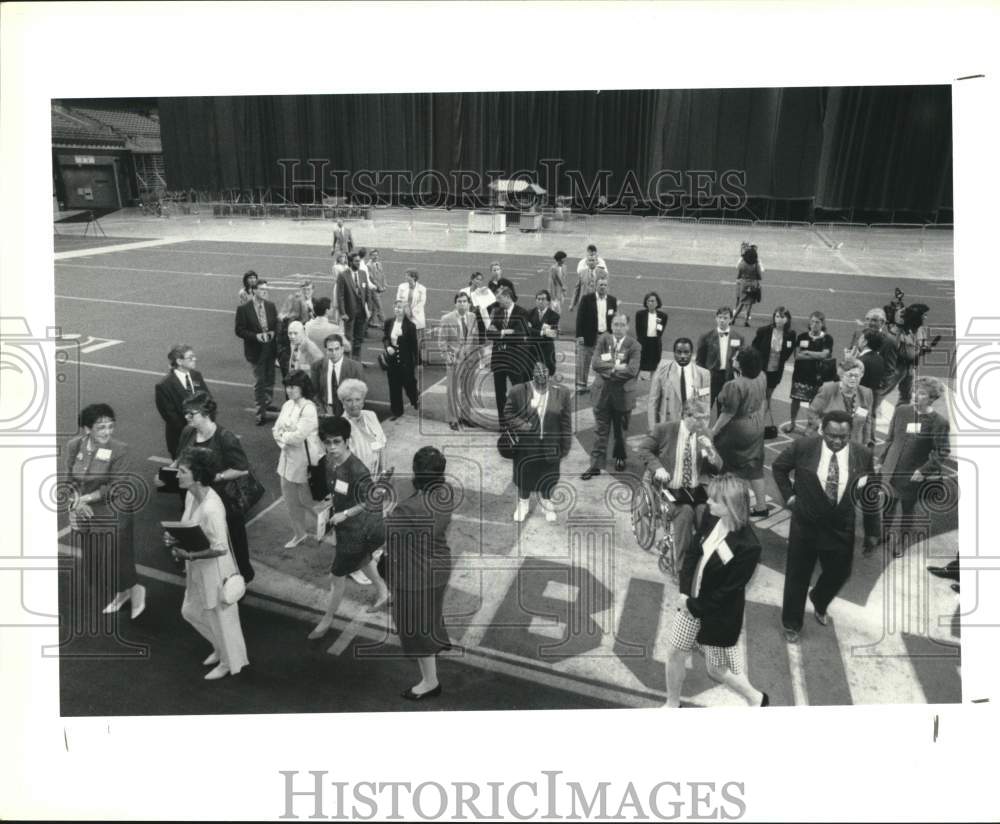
[666,474,771,707]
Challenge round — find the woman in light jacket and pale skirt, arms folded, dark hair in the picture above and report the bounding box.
[272,371,324,549]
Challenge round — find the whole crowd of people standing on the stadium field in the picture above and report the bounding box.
[66,235,949,706]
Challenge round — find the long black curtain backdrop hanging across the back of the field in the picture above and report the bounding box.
[159,86,952,212]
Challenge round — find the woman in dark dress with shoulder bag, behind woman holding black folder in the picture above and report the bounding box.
[172,392,256,584]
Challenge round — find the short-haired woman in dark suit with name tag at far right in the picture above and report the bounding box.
[875,377,951,558]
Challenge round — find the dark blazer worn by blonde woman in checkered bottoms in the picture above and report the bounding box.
[680,512,760,647]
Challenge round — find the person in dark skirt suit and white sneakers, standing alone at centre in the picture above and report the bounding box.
[505,352,573,523]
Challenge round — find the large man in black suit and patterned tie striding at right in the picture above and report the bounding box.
[771,409,881,643]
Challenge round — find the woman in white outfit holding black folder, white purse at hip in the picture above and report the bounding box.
[163,446,250,681]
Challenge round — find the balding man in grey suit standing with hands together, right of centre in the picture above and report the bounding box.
[580,312,642,481]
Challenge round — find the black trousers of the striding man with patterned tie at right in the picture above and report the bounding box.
[781,525,854,632]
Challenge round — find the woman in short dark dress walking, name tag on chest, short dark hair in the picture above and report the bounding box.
[309,418,389,640]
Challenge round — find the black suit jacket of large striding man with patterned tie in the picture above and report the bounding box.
[771,437,881,552]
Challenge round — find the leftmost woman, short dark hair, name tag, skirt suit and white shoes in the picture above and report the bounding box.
[65,403,146,620]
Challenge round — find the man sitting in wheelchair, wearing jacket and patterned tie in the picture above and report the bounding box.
[636,398,722,570]
